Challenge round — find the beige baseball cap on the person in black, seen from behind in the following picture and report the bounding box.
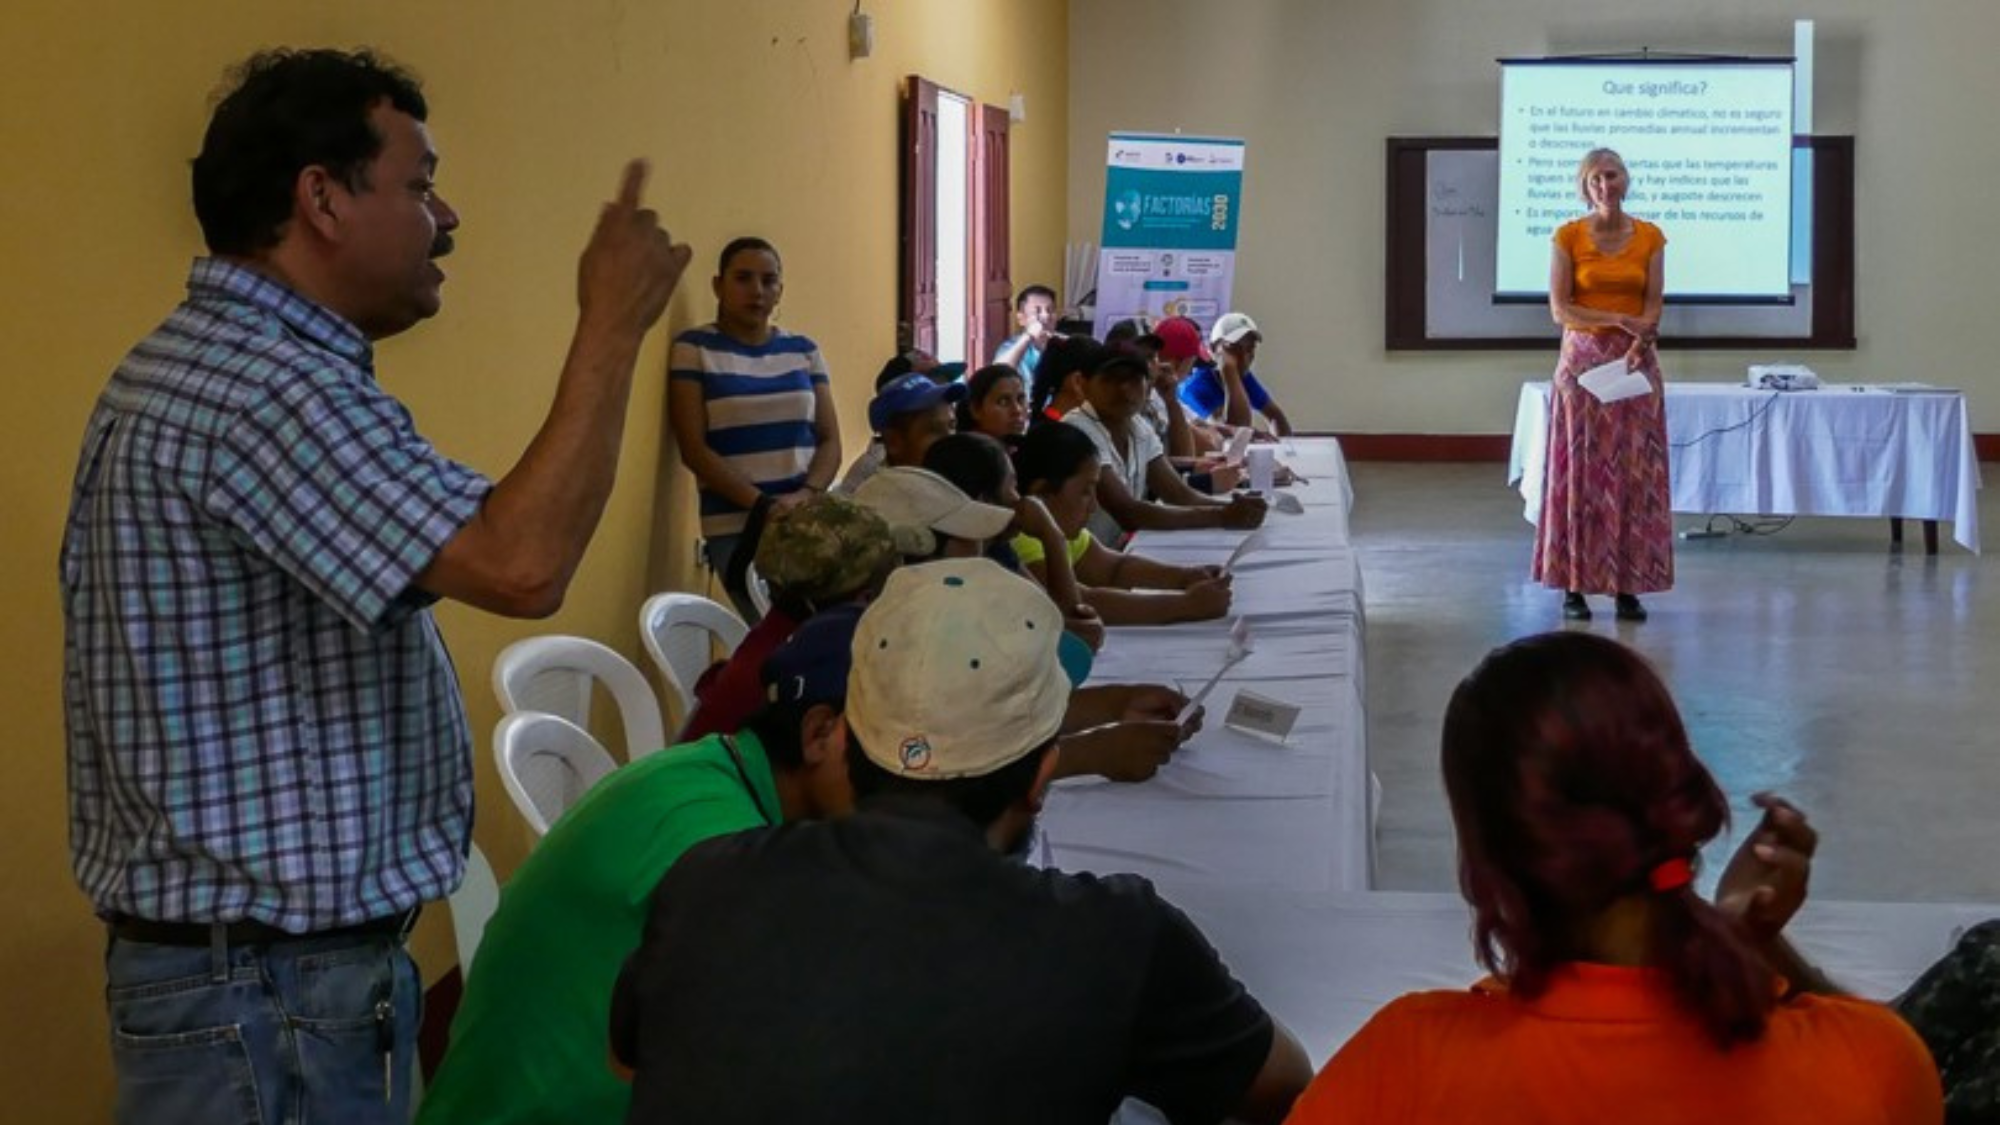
[846,558,1070,781]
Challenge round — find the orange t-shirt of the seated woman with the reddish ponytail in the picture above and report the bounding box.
[1286,952,1944,1125]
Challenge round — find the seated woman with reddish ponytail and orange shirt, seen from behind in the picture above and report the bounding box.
[1290,633,1944,1125]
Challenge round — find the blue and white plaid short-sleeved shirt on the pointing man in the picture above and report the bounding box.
[62,258,492,933]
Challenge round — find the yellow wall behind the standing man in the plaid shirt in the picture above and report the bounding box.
[0,0,1068,1123]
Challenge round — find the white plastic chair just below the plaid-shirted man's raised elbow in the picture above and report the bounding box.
[494,635,666,761]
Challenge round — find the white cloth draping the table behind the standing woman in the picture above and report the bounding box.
[1508,382,1980,554]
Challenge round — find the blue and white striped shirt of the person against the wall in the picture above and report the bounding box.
[668,324,826,534]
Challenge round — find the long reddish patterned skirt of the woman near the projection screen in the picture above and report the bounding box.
[1532,332,1674,595]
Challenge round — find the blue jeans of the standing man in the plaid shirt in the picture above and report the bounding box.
[104,935,422,1125]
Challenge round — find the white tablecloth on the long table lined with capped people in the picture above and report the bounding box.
[1042,438,1374,891]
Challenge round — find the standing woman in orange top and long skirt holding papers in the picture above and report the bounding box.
[1532,148,1674,621]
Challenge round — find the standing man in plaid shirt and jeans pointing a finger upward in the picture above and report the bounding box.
[62,50,688,1123]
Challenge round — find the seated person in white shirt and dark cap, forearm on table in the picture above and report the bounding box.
[1062,344,1266,544]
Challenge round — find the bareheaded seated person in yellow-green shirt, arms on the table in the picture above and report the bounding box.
[1014,424,1230,625]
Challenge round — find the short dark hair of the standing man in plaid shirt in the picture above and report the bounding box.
[194,50,430,254]
